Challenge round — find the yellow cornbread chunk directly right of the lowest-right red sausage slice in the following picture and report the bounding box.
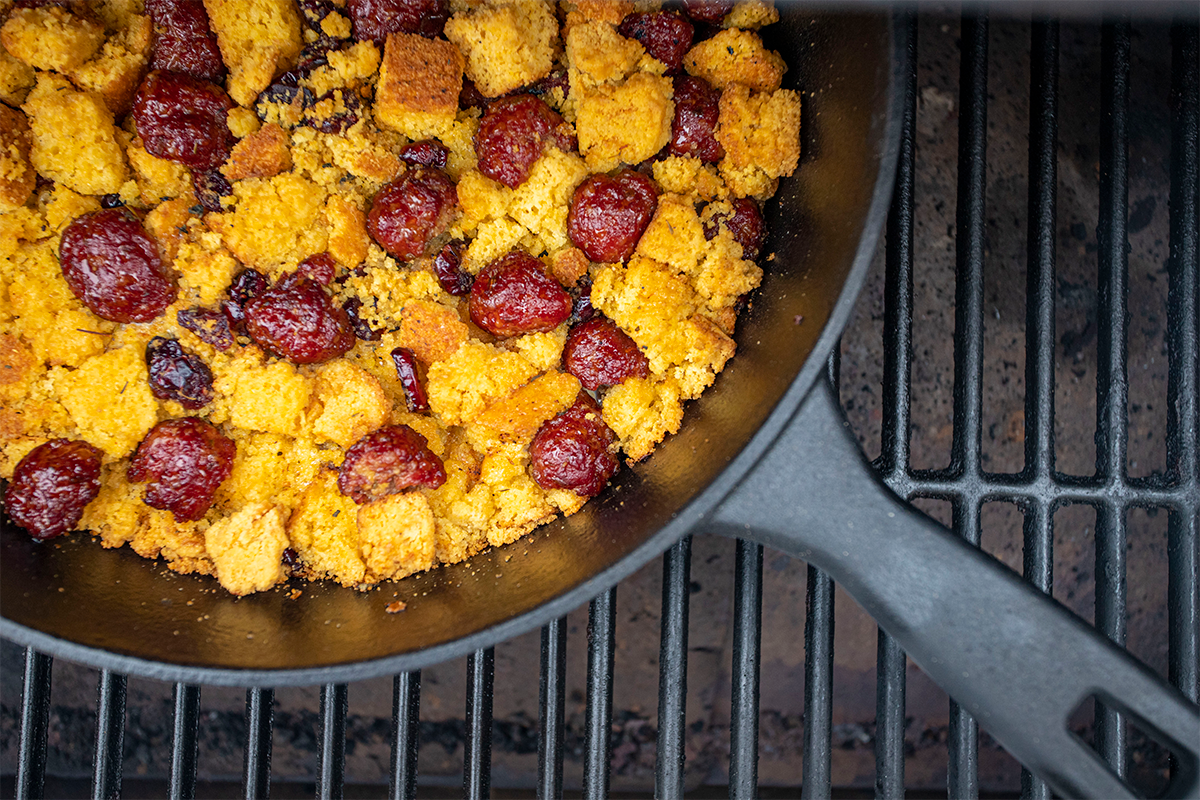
[604,378,683,464]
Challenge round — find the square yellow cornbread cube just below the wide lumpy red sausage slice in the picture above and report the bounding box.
[212,348,313,435]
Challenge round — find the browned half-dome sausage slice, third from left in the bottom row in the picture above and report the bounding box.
[337,425,446,504]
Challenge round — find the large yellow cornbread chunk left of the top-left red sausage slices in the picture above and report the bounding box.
[22,73,128,194]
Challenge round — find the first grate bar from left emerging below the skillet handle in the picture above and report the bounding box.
[730,540,762,800]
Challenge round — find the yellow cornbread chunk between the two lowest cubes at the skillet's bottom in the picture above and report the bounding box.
[287,469,366,587]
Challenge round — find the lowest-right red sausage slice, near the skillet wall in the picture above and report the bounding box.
[529,392,617,498]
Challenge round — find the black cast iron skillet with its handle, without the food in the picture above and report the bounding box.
[0,8,1200,800]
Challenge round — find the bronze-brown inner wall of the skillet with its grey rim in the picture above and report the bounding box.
[0,6,890,685]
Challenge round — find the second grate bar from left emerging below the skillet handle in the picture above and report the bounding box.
[800,566,833,800]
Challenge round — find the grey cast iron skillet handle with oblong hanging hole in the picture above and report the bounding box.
[708,380,1200,800]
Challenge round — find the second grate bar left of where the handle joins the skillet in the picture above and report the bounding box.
[583,587,617,800]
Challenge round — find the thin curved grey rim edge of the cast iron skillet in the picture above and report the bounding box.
[0,13,911,687]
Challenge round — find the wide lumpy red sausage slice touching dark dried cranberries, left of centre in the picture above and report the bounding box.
[246,272,354,363]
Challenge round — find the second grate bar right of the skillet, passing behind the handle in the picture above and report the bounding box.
[948,16,988,800]
